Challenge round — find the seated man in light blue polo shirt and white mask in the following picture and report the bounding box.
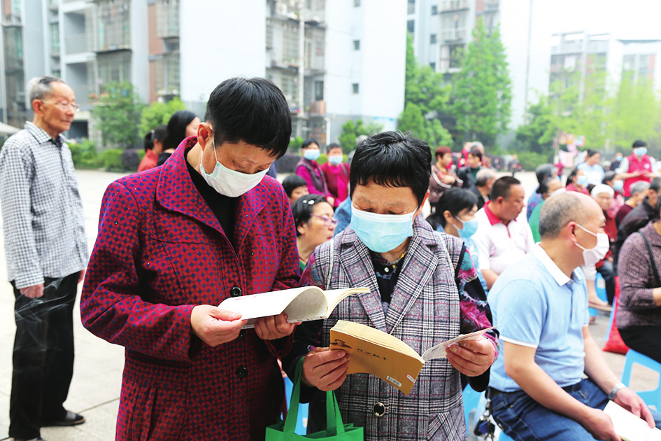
[489,192,661,441]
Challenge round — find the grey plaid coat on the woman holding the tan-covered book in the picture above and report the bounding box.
[309,217,466,440]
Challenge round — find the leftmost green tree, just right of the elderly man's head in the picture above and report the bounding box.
[92,82,144,148]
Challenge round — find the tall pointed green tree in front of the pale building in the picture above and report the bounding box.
[452,19,512,145]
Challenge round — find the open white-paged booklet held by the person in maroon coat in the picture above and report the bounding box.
[218,286,370,329]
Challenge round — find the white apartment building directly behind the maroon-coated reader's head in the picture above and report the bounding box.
[180,0,406,144]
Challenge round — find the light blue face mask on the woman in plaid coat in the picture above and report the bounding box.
[351,206,415,253]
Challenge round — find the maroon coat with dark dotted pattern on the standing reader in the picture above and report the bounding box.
[81,138,299,441]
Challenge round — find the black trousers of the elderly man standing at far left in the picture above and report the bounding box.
[9,273,78,439]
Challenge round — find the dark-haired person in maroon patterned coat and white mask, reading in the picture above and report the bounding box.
[80,79,299,440]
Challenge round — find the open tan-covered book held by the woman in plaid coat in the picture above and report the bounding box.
[330,320,495,395]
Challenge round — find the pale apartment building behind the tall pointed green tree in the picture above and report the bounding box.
[407,0,551,129]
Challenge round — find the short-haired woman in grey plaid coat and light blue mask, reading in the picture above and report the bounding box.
[283,132,498,440]
